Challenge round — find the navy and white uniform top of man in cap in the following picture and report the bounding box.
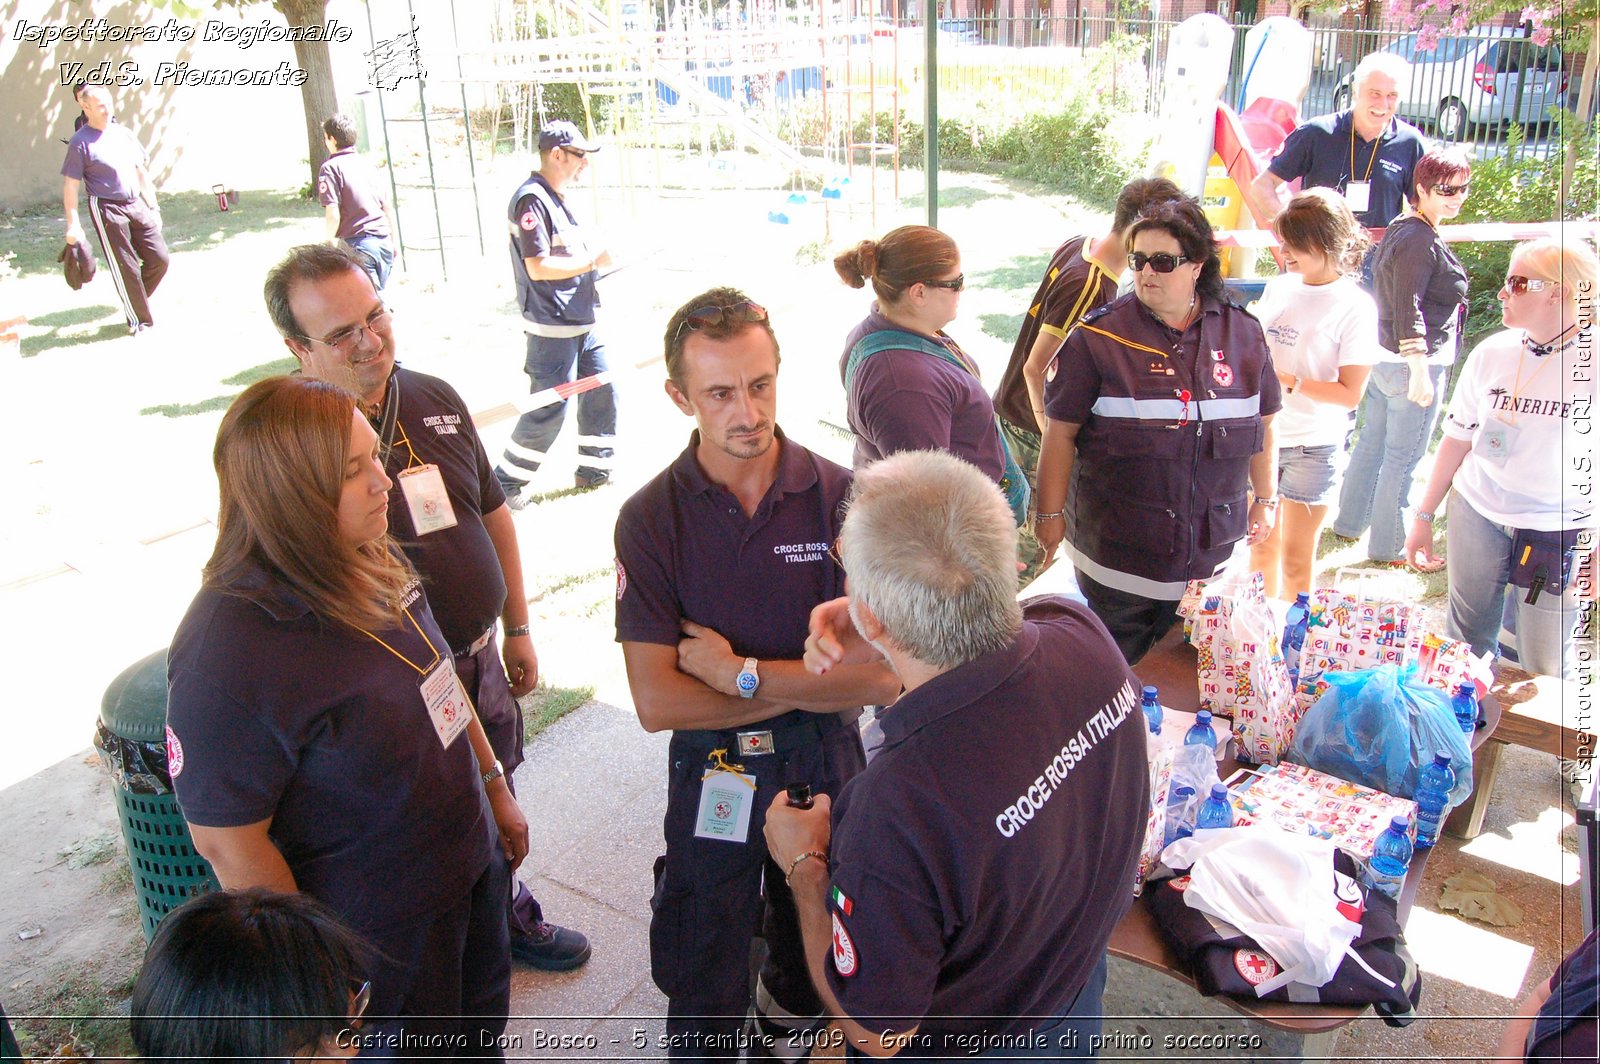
[507,173,600,329]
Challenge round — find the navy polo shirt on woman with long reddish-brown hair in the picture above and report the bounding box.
[166,573,496,934]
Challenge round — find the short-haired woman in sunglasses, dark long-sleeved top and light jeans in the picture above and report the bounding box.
[1333,147,1472,565]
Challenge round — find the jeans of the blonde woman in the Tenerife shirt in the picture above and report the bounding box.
[1445,491,1582,680]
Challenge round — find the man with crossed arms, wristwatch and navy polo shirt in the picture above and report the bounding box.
[616,288,899,1059]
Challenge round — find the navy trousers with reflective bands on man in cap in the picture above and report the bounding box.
[494,330,616,494]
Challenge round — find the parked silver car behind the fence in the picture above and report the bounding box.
[1333,26,1566,141]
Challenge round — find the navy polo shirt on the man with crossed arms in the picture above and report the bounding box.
[616,430,850,665]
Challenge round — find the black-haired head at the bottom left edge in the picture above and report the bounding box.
[130,888,371,1064]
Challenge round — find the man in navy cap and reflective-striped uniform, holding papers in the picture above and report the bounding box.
[494,122,616,510]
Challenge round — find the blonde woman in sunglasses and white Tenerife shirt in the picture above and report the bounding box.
[1405,238,1600,678]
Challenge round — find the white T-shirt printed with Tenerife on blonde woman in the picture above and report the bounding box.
[1445,330,1595,531]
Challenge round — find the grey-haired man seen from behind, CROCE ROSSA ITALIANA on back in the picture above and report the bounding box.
[766,451,1149,1061]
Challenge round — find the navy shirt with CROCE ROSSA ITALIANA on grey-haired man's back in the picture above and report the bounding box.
[827,597,1149,1058]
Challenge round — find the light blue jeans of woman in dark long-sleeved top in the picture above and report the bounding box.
[1333,362,1450,562]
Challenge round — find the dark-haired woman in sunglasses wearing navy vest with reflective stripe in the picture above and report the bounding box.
[1035,197,1278,664]
